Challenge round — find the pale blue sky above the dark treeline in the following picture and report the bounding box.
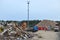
[0,0,60,21]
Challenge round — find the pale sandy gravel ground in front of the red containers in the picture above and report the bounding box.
[32,31,60,40]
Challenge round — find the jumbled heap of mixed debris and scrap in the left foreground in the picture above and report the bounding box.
[0,24,34,40]
